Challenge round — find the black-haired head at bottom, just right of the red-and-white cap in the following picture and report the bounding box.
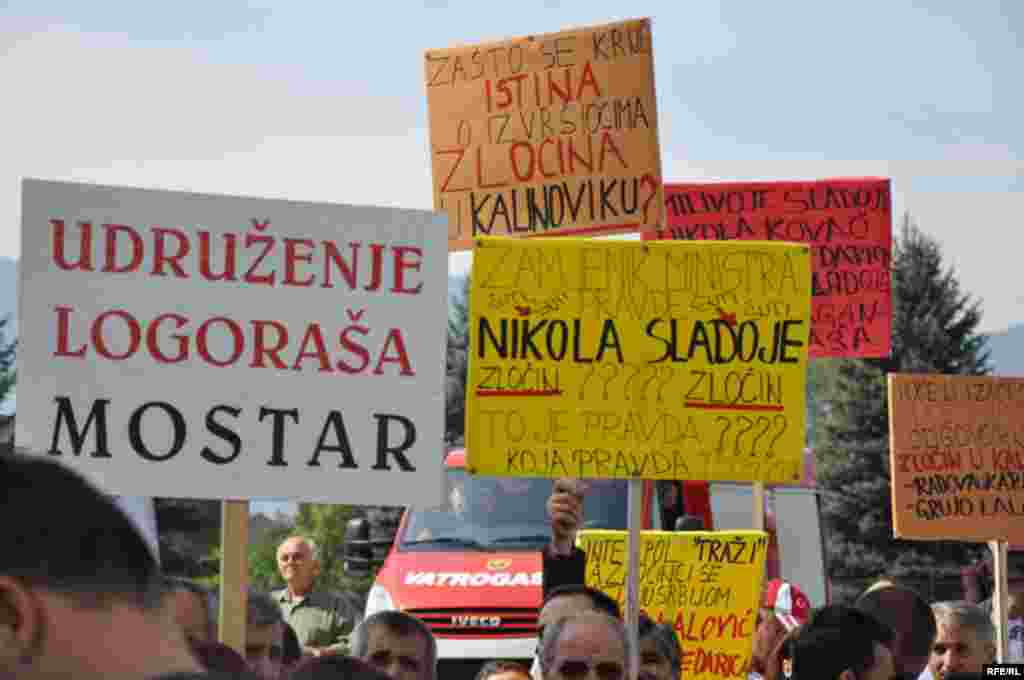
[784,604,893,680]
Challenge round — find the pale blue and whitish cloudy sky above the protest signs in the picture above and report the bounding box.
[0,0,1024,516]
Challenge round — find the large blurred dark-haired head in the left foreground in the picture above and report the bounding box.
[0,454,200,679]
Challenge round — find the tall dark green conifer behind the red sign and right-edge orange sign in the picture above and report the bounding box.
[817,215,989,595]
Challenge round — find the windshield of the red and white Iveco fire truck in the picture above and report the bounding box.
[399,468,628,552]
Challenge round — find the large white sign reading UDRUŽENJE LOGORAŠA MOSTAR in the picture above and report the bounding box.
[15,180,447,505]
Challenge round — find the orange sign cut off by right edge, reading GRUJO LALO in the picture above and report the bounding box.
[889,374,1024,543]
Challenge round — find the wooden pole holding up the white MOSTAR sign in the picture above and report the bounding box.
[217,501,249,657]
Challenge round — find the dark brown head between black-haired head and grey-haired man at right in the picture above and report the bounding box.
[854,580,935,680]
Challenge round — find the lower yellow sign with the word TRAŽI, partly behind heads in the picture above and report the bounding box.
[577,530,768,680]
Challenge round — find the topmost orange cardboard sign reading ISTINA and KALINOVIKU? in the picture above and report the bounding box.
[424,18,665,251]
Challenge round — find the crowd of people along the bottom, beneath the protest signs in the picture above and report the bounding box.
[0,454,1024,680]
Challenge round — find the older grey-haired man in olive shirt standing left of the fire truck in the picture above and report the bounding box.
[270,536,360,656]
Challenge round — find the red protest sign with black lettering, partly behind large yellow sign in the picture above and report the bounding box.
[643,178,892,357]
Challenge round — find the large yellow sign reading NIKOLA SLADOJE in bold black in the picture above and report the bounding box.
[466,238,811,482]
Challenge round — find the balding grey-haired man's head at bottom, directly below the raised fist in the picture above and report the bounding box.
[541,611,634,680]
